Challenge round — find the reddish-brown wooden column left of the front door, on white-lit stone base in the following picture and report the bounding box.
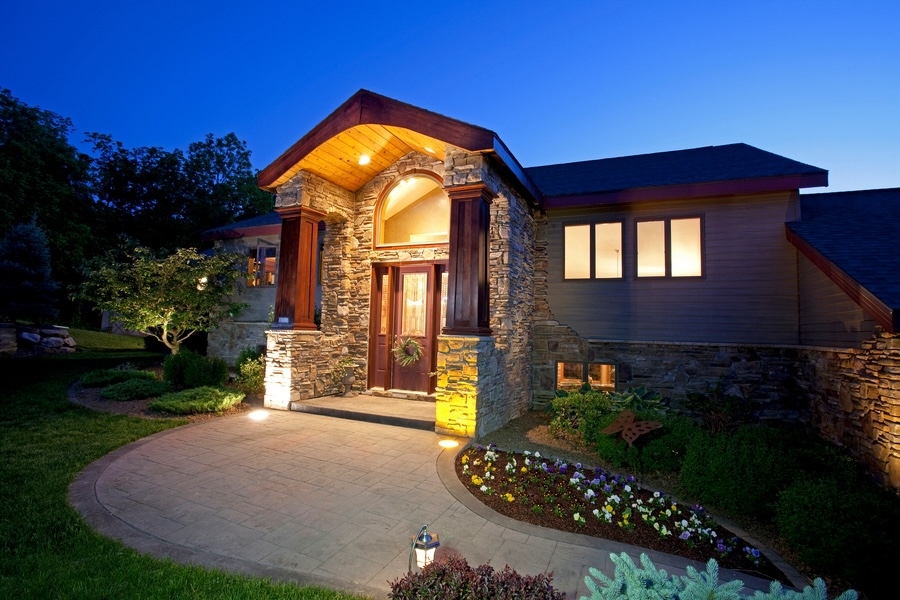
[273,206,325,329]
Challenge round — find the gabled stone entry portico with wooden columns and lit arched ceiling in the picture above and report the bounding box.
[259,91,540,436]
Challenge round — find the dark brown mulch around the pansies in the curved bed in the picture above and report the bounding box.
[456,447,791,585]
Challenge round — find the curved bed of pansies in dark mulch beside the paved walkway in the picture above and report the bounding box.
[456,445,790,584]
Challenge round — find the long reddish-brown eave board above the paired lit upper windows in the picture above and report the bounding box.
[544,171,828,210]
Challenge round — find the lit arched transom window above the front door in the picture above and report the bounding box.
[375,173,450,246]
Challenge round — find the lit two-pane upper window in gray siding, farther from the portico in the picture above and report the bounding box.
[637,217,703,277]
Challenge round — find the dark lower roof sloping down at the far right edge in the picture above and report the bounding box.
[787,188,900,331]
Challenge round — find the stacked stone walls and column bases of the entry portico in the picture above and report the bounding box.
[266,147,534,435]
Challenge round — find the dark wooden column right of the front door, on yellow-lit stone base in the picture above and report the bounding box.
[441,183,495,335]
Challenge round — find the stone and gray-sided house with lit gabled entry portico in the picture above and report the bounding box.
[225,90,900,486]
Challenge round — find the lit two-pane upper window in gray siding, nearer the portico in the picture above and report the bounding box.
[563,222,622,279]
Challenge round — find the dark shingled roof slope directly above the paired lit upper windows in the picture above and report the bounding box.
[525,144,828,198]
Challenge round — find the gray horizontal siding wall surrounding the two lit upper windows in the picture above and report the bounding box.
[547,194,799,344]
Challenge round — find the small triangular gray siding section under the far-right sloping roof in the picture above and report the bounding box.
[799,257,876,348]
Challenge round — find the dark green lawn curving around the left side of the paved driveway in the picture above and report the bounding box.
[0,354,370,600]
